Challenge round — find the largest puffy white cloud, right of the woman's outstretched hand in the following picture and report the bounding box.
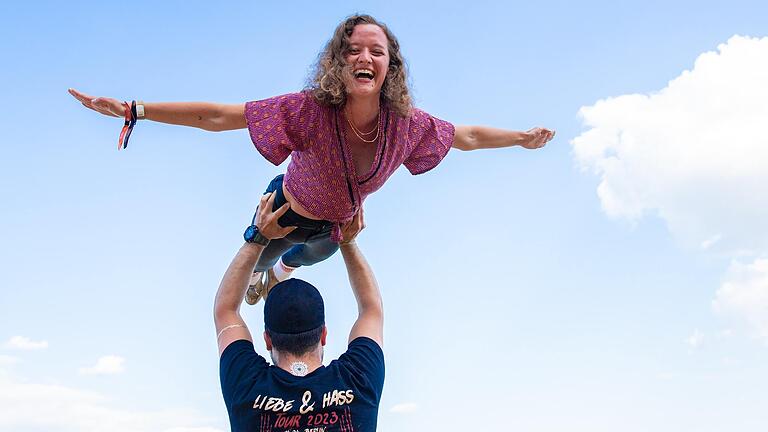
[571,36,768,252]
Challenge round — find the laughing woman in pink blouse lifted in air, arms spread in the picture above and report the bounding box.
[69,15,554,304]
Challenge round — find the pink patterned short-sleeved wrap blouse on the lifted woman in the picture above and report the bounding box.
[245,92,454,241]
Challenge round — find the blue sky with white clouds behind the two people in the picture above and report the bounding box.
[0,1,768,432]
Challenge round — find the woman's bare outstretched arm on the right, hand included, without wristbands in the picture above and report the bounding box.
[453,126,555,151]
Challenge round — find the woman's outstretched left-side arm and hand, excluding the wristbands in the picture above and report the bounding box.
[69,89,246,132]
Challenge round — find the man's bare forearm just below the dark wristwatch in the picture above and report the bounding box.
[213,243,264,318]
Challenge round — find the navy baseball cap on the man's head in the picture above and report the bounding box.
[264,279,325,334]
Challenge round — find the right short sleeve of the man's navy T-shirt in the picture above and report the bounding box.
[339,336,384,402]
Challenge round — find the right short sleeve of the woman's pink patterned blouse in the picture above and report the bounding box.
[403,108,455,175]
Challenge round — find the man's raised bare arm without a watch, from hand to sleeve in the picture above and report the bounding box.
[341,208,384,347]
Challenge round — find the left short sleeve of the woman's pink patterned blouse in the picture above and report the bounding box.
[245,92,321,165]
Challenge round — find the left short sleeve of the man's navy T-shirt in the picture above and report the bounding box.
[219,339,269,407]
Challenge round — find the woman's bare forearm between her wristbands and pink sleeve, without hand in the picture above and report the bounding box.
[144,102,246,132]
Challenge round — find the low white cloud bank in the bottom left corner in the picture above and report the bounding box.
[0,364,223,432]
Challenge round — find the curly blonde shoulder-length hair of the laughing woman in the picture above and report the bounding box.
[307,15,413,117]
